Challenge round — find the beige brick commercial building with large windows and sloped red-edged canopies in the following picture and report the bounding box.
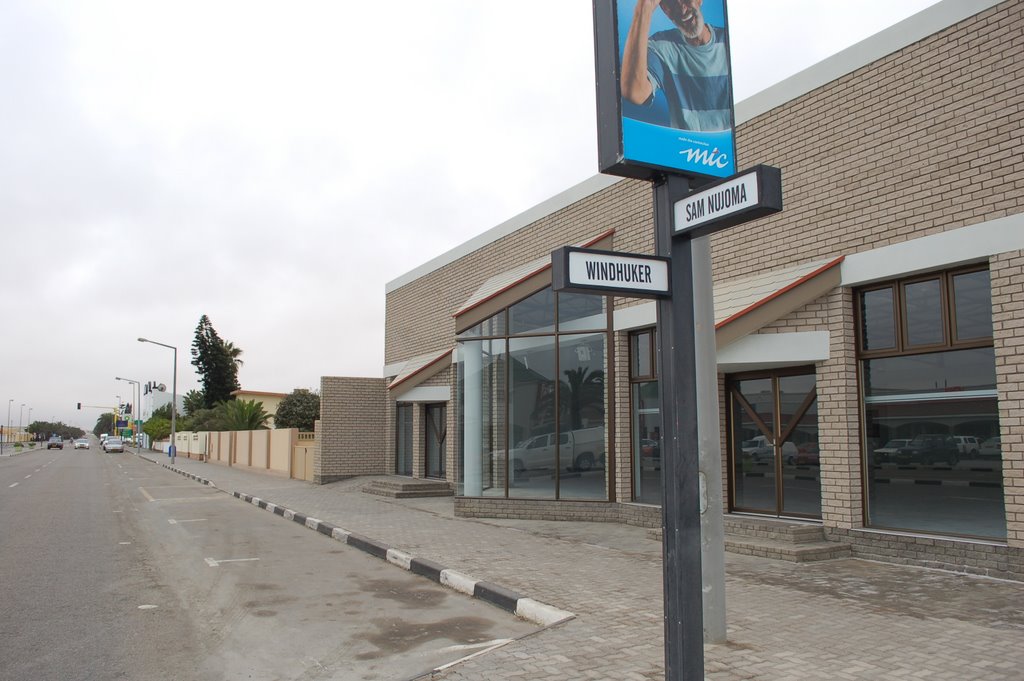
[316,0,1024,579]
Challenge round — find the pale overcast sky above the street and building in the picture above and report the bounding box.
[0,0,935,430]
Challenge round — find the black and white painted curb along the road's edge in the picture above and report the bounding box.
[148,455,575,627]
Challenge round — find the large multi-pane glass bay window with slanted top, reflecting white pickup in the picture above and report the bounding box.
[457,287,608,500]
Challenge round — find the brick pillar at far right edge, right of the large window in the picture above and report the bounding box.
[989,251,1024,548]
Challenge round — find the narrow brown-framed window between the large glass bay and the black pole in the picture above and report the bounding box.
[630,329,662,504]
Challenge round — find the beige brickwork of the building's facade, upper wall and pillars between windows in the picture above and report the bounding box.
[385,0,1024,545]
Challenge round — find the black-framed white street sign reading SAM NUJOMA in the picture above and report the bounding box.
[674,165,782,238]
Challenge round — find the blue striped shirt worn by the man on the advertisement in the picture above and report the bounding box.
[647,25,732,130]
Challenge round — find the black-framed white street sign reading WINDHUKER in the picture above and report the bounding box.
[551,246,672,298]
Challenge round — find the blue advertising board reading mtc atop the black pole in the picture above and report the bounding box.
[594,0,736,179]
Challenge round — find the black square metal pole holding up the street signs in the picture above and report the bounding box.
[654,175,703,681]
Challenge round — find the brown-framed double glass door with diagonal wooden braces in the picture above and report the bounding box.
[727,369,821,518]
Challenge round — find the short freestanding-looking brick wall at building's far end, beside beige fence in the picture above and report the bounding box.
[313,376,387,484]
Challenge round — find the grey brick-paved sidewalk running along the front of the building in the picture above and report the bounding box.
[138,453,1024,681]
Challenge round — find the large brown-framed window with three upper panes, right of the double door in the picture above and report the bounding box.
[857,267,1007,539]
